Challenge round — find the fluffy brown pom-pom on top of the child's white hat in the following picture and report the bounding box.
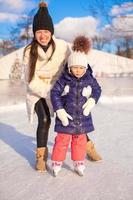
[72,36,91,54]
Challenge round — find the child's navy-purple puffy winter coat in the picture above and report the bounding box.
[51,67,101,134]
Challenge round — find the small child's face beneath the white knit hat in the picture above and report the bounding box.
[70,65,86,78]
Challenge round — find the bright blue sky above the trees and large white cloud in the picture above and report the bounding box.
[0,0,133,39]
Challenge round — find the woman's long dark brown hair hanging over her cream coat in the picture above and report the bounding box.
[24,38,55,83]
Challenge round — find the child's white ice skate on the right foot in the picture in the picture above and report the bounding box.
[74,161,85,176]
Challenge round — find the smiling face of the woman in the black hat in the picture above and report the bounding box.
[35,30,51,46]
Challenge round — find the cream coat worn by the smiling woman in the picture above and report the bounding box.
[23,37,69,123]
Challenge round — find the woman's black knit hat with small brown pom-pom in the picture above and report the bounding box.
[33,2,54,35]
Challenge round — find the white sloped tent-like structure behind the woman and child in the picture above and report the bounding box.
[0,45,133,80]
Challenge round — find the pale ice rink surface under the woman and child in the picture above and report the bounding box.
[0,102,133,200]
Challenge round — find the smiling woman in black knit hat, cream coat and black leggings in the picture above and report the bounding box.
[24,2,102,171]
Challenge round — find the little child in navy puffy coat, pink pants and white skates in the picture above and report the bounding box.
[51,36,101,176]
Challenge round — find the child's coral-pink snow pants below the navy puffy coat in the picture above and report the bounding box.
[51,133,87,161]
